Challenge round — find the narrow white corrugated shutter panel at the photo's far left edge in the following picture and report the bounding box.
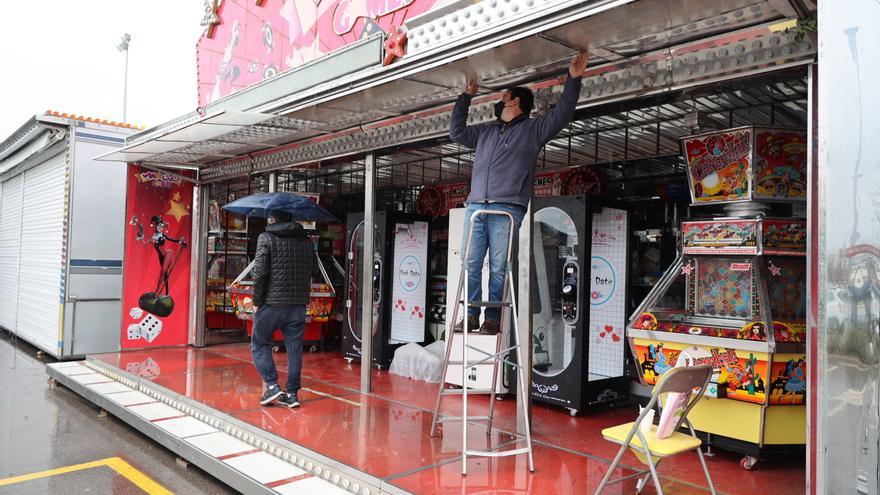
[0,175,23,332]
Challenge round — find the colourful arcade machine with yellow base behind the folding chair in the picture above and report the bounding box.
[627,127,807,469]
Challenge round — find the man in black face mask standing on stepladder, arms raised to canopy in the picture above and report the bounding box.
[449,51,589,335]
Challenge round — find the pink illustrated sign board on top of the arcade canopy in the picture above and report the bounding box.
[197,0,460,105]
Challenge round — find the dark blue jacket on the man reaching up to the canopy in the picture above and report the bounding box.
[449,77,581,206]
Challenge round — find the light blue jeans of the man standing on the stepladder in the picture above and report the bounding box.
[461,203,526,321]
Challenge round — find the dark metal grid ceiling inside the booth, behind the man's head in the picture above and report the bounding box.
[279,68,807,194]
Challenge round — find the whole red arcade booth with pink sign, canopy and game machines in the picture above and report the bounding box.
[46,0,840,495]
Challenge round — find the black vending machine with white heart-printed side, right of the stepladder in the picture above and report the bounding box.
[532,195,630,415]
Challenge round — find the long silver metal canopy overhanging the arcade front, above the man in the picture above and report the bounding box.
[111,0,815,185]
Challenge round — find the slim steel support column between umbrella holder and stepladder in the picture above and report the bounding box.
[360,152,376,393]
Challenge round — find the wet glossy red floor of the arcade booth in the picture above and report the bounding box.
[92,344,805,494]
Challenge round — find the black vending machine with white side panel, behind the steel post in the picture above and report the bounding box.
[342,211,430,369]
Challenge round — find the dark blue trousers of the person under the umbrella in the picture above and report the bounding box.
[251,304,306,394]
